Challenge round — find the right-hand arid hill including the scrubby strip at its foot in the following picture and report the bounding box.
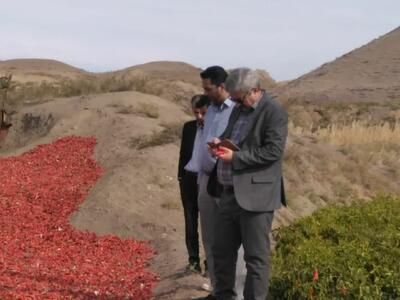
[273,28,400,129]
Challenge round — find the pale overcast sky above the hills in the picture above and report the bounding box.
[0,0,400,80]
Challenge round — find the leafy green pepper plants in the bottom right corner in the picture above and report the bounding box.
[270,195,400,299]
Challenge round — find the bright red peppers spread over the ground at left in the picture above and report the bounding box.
[0,137,157,299]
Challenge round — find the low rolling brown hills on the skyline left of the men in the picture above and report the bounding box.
[0,59,202,110]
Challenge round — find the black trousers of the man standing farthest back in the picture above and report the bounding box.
[179,172,200,263]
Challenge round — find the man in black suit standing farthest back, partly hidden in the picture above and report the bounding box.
[178,95,210,273]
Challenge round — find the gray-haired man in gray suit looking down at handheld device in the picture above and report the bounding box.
[209,68,288,300]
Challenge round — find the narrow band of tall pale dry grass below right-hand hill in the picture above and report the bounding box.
[289,121,400,146]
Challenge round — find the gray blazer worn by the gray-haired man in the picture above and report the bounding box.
[220,93,288,212]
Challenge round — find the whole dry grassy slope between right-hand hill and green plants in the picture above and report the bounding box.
[284,122,400,215]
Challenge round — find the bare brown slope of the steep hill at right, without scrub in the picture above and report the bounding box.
[281,27,400,102]
